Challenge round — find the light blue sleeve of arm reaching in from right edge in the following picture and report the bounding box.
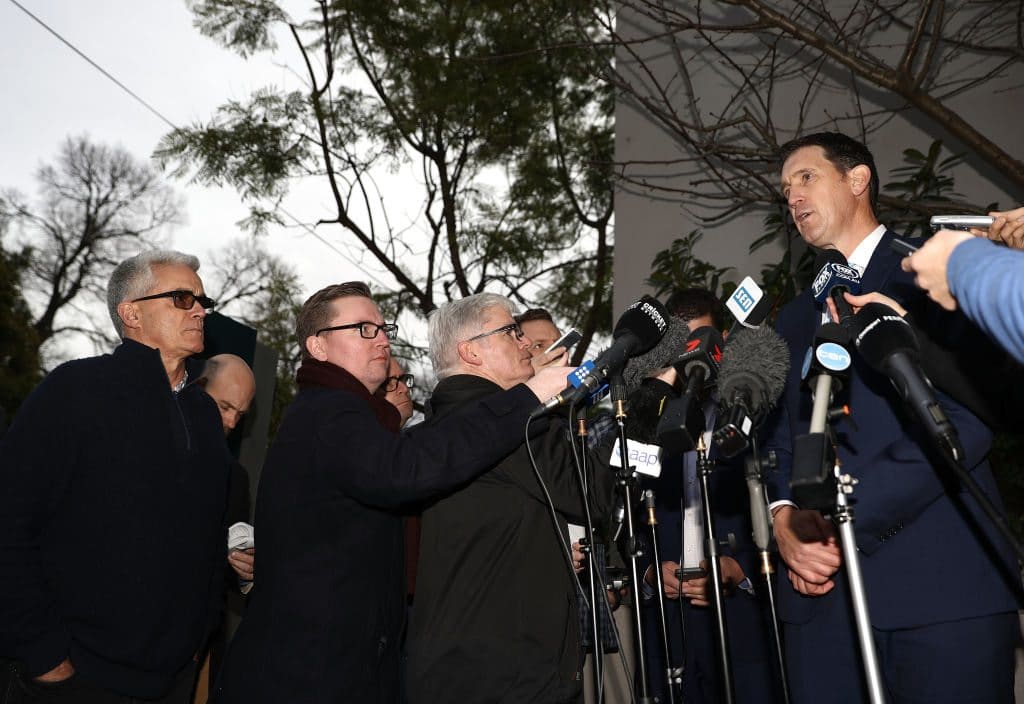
[946,237,1024,363]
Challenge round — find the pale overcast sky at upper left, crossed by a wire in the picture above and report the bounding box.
[0,0,419,354]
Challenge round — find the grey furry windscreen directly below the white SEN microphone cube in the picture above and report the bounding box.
[718,326,790,413]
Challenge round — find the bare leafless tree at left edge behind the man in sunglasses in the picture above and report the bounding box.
[0,136,179,358]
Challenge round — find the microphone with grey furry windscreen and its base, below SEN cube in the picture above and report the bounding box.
[712,327,790,458]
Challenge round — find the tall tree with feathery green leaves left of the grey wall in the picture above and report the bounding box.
[171,0,614,358]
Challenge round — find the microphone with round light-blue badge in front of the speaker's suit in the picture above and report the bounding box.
[790,322,853,511]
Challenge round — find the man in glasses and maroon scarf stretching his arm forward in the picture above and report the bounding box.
[207,282,569,704]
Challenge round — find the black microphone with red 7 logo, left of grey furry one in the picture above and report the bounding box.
[657,325,725,453]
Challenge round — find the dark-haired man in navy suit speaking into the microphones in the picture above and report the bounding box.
[769,133,1020,704]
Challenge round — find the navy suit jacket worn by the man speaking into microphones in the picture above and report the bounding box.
[766,231,1020,629]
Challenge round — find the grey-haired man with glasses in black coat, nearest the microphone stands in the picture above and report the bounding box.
[408,294,612,704]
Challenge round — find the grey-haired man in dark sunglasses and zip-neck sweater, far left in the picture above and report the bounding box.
[0,251,229,704]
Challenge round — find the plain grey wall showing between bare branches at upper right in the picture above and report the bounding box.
[614,2,1024,314]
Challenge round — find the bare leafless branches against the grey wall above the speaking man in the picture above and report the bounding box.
[606,0,1024,223]
